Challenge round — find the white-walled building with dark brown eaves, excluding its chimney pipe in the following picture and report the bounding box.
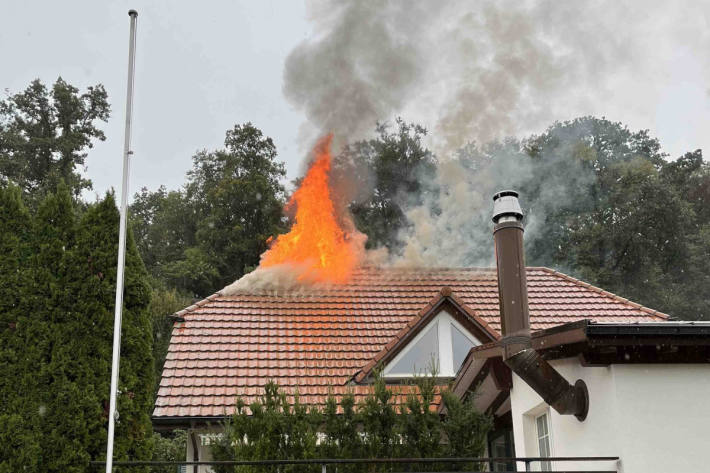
[453,320,710,472]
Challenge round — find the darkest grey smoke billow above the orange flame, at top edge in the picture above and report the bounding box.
[283,1,436,148]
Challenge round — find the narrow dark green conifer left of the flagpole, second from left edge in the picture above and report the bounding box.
[33,184,92,472]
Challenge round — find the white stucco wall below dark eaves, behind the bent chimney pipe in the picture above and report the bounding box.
[511,359,710,473]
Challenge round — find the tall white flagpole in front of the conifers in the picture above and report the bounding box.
[106,10,138,473]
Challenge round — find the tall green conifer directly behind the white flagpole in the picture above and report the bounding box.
[65,194,153,460]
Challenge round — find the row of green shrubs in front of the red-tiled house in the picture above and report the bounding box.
[211,376,492,473]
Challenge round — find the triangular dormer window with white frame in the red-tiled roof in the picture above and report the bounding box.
[383,310,481,378]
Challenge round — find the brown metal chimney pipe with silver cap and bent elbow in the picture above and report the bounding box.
[493,190,589,421]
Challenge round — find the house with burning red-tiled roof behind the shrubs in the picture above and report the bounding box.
[153,268,666,468]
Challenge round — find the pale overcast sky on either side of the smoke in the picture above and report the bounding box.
[0,0,710,199]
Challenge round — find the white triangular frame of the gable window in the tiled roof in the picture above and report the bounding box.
[382,310,481,378]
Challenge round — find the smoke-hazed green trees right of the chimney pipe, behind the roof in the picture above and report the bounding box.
[521,117,710,319]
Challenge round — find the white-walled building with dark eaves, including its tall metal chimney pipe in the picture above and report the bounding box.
[454,191,710,472]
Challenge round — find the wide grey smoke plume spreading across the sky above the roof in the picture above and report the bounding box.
[284,0,710,266]
